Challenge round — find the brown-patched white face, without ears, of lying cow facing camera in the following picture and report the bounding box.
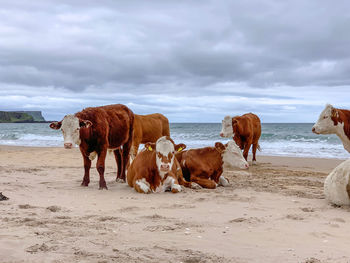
[156,136,175,177]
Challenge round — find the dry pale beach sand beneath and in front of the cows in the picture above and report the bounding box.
[0,146,350,263]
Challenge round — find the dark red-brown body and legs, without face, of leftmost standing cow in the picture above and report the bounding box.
[75,104,134,189]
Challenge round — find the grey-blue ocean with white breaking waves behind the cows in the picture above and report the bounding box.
[0,123,350,158]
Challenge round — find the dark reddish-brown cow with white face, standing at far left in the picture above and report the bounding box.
[50,104,134,189]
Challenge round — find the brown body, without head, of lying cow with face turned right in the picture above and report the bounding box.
[176,147,223,189]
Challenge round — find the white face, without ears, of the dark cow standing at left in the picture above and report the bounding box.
[61,115,81,145]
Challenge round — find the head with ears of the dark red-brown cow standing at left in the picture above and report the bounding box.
[50,115,92,149]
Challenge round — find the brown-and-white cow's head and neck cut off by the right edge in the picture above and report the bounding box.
[312,104,350,153]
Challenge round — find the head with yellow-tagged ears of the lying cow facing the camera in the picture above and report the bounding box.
[145,136,186,177]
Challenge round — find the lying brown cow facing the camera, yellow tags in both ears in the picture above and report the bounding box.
[127,136,196,194]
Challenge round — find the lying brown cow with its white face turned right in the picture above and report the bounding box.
[176,141,249,189]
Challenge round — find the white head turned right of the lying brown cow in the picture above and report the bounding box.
[215,141,249,169]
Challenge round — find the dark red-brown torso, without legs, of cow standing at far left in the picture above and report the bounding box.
[76,104,134,148]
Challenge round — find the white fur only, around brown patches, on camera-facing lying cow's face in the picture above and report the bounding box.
[156,136,175,179]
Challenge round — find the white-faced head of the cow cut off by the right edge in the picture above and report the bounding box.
[312,104,339,134]
